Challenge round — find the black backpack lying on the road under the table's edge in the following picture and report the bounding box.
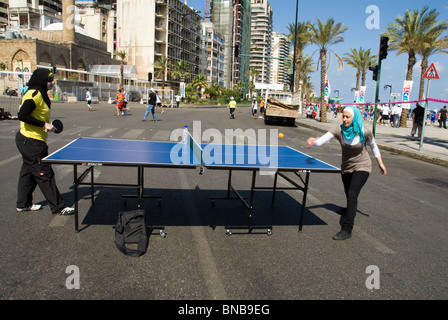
[115,209,148,257]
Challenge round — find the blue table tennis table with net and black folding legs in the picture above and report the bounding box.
[42,135,340,234]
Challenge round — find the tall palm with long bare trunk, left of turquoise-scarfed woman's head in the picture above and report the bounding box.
[310,18,348,122]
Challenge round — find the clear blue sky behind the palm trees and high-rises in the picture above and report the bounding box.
[188,0,448,109]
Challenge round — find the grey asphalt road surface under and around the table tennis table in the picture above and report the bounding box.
[0,102,448,301]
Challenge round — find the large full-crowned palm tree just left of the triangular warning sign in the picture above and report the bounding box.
[384,6,444,127]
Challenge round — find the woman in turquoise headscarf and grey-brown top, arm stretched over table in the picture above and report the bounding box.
[308,106,387,240]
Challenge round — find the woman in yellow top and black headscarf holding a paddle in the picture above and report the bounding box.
[16,68,75,215]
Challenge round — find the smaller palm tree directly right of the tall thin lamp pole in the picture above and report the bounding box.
[286,21,311,92]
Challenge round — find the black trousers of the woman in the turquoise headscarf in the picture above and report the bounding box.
[341,171,369,232]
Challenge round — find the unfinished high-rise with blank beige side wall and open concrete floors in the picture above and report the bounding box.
[116,0,202,87]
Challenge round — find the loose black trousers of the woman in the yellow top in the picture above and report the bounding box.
[16,131,66,213]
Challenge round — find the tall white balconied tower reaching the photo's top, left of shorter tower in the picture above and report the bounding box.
[250,0,273,83]
